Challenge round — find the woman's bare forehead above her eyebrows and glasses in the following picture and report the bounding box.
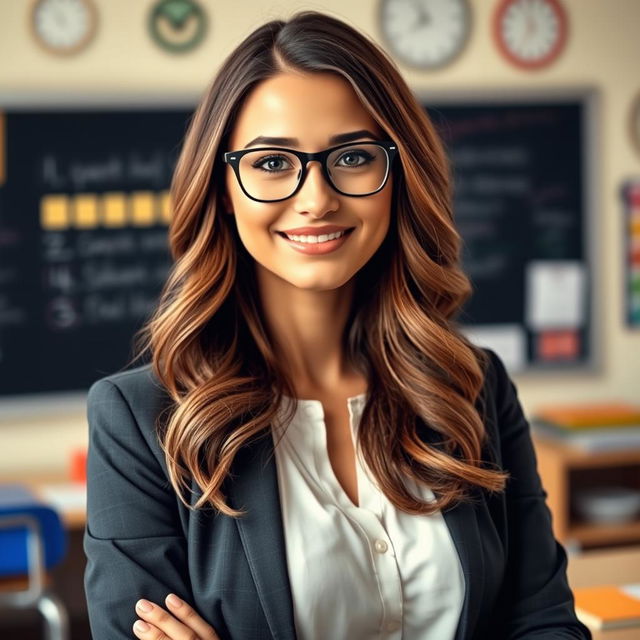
[230,73,382,150]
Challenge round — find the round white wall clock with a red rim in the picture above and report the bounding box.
[493,0,567,69]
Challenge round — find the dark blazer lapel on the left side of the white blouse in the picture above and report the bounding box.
[226,431,296,640]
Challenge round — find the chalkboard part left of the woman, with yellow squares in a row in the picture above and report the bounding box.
[0,97,193,396]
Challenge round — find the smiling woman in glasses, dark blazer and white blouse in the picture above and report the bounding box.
[85,12,590,640]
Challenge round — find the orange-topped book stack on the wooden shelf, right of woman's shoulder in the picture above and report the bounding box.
[531,402,640,453]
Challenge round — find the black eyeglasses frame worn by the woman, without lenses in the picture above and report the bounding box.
[222,140,398,202]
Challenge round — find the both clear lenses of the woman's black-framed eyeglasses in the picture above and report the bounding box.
[239,143,389,200]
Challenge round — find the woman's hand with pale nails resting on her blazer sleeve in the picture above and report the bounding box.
[133,593,220,640]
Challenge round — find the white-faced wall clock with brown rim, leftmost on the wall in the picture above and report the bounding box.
[31,0,98,55]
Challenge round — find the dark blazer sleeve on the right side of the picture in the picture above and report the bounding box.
[487,350,591,640]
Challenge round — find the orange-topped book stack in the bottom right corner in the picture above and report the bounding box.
[573,583,640,638]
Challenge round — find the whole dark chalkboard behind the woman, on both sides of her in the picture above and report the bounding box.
[0,92,594,398]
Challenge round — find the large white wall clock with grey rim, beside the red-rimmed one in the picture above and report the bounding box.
[380,0,471,69]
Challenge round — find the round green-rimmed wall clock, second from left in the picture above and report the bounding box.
[149,0,207,53]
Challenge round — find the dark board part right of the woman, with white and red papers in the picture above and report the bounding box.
[421,89,598,372]
